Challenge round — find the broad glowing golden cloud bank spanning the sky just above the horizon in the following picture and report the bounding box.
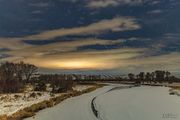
[1,34,180,72]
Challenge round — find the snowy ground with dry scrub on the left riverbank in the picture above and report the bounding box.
[0,85,93,115]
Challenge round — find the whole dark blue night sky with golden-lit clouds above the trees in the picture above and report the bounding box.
[0,0,180,76]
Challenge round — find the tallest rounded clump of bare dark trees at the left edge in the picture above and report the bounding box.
[0,62,37,92]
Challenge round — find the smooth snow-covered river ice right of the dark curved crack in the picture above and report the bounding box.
[95,86,180,120]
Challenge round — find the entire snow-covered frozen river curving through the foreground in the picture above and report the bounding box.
[26,85,180,120]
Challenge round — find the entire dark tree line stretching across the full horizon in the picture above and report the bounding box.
[0,62,180,93]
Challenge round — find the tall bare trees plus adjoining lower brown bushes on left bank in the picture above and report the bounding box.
[0,62,73,93]
